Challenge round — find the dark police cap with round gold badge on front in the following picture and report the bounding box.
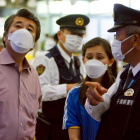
[56,14,89,34]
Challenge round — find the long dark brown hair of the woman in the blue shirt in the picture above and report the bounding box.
[79,37,115,105]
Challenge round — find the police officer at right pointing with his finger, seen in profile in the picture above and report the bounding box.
[86,4,140,140]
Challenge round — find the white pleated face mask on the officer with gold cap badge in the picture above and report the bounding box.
[60,32,82,52]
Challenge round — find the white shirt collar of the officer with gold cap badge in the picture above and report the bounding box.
[57,44,74,63]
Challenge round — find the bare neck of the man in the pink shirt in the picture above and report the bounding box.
[6,48,26,72]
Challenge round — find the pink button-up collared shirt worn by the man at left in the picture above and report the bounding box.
[0,49,42,140]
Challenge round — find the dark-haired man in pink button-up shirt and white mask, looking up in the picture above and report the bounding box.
[0,9,41,140]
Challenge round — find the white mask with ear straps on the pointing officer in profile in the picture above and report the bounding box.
[111,35,134,61]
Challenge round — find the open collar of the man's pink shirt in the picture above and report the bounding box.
[0,48,31,71]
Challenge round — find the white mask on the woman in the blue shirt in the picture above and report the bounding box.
[85,59,107,79]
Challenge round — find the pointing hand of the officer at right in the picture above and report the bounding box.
[85,82,107,106]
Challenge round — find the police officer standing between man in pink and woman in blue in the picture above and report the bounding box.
[34,14,89,140]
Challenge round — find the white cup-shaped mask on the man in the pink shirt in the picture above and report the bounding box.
[8,29,34,54]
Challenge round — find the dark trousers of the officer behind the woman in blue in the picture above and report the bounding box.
[36,117,69,140]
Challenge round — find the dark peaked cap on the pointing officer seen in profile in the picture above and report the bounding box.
[108,4,140,32]
